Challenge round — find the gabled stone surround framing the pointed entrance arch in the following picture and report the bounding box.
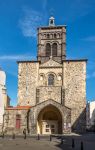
[30,99,71,134]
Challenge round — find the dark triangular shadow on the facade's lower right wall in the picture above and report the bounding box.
[72,108,86,133]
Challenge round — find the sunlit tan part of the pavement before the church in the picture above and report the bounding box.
[0,138,60,150]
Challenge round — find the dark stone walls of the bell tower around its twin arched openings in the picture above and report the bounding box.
[38,26,66,63]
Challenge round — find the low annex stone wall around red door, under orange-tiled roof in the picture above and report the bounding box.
[3,109,28,134]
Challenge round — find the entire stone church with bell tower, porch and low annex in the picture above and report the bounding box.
[3,17,87,134]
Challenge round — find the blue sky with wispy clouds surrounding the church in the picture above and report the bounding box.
[0,0,95,105]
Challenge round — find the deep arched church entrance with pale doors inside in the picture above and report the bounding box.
[37,105,62,135]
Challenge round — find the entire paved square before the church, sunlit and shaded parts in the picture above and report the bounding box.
[0,134,95,150]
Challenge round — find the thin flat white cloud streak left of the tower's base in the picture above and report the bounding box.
[0,54,35,61]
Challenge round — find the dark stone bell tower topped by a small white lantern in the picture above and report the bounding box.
[37,17,66,63]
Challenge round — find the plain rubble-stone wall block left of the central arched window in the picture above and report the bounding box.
[18,62,39,106]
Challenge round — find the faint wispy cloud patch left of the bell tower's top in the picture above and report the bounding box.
[19,7,46,37]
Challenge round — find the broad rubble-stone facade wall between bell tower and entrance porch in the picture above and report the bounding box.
[18,60,86,131]
